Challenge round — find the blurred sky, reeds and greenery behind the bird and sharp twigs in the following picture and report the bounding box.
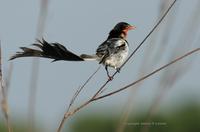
[0,0,200,132]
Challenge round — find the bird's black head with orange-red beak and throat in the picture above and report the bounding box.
[108,22,136,39]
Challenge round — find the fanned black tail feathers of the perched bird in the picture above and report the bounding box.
[10,39,84,61]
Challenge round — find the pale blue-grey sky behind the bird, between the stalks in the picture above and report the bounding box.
[0,0,200,130]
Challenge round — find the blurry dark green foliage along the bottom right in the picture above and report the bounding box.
[71,104,200,132]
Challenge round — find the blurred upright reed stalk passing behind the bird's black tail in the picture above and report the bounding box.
[28,0,49,132]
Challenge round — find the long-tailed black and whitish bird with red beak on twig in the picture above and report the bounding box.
[9,22,136,80]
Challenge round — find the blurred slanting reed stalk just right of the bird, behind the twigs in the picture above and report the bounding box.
[118,0,178,132]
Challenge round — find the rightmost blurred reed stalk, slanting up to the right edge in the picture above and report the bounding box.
[142,2,200,132]
